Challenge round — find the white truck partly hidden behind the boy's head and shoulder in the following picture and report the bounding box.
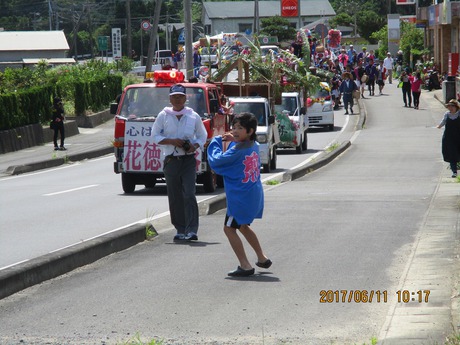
[229,96,280,173]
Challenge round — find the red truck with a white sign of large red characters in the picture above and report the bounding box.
[110,70,230,193]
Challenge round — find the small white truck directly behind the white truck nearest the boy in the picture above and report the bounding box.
[275,92,308,153]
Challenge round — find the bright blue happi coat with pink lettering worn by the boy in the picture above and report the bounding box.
[208,136,264,224]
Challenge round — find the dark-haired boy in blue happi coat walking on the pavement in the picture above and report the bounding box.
[208,113,272,277]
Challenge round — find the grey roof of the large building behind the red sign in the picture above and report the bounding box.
[203,0,335,19]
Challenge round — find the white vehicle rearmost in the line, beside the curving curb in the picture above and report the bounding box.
[307,82,334,131]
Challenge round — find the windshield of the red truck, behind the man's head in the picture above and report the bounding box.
[120,87,207,118]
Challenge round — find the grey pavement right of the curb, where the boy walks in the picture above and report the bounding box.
[0,86,459,345]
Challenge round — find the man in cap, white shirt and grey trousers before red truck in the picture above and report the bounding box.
[152,84,207,241]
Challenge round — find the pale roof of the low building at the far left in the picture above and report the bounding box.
[0,31,69,51]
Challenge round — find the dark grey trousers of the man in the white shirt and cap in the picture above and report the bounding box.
[163,155,199,234]
